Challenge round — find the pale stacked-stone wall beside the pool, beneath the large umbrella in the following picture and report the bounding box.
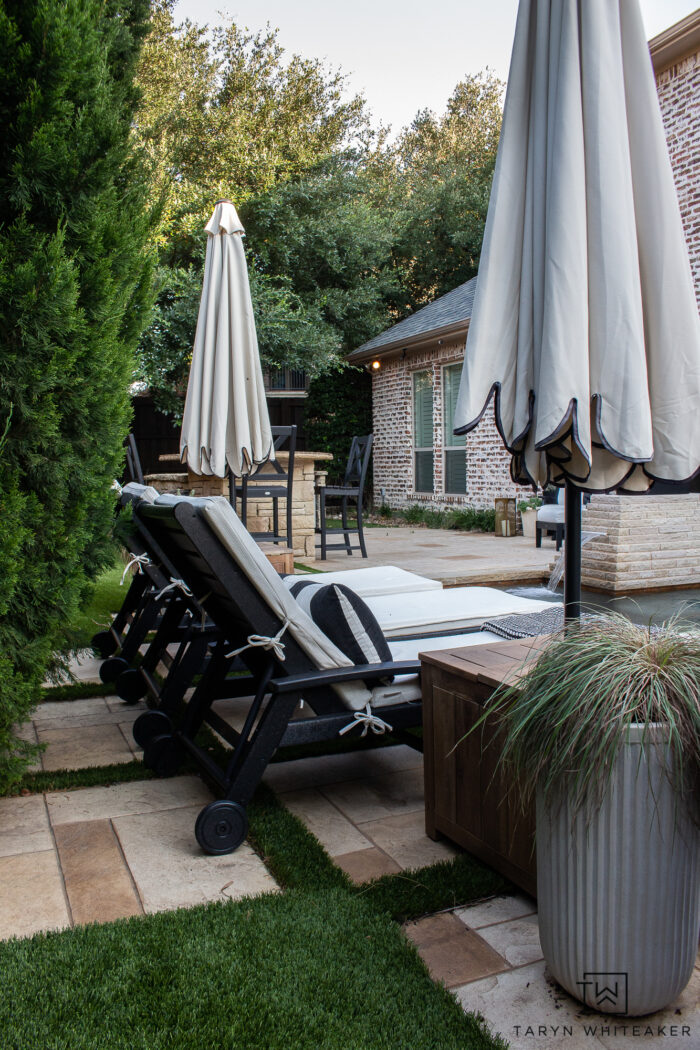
[581,494,700,593]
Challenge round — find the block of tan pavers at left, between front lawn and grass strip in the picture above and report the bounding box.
[0,776,277,938]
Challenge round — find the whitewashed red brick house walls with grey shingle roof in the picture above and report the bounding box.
[349,11,700,507]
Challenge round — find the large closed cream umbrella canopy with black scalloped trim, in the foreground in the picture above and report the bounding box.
[454,0,700,491]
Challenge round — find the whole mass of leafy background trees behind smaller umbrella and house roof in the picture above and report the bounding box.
[132,0,502,443]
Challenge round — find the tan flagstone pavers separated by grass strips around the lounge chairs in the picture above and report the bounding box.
[0,660,700,1050]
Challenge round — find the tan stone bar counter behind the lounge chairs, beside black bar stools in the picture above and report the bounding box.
[145,449,333,558]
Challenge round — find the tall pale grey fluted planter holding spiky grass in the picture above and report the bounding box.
[536,727,700,1015]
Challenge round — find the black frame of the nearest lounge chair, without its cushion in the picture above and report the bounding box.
[133,502,422,854]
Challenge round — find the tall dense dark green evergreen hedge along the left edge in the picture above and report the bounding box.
[0,0,151,789]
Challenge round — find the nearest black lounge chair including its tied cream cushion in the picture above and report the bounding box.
[134,498,428,854]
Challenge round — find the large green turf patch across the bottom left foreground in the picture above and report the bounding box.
[0,889,506,1050]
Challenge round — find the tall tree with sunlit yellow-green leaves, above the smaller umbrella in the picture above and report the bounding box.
[136,0,372,266]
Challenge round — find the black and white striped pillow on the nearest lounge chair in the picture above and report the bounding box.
[290,580,393,667]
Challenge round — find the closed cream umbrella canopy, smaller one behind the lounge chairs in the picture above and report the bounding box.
[179,201,274,478]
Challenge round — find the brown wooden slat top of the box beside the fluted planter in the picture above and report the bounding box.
[419,635,549,688]
